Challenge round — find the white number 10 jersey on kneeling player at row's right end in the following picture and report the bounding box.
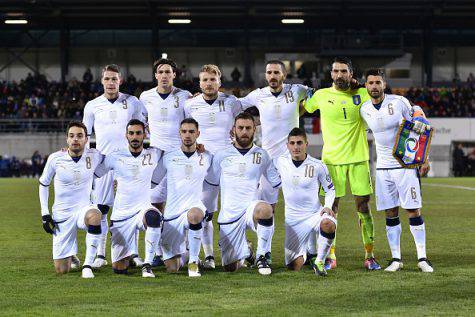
[274,154,335,219]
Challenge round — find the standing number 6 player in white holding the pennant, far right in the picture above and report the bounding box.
[360,69,434,273]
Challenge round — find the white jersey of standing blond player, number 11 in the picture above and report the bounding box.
[185,92,242,154]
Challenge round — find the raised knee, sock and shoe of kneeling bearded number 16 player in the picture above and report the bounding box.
[253,202,274,275]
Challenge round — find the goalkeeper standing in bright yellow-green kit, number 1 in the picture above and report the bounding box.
[305,57,381,270]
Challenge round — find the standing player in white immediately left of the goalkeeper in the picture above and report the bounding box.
[239,60,309,262]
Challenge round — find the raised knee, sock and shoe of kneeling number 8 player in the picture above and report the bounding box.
[81,209,102,278]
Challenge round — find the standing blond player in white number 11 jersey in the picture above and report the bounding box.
[185,65,242,269]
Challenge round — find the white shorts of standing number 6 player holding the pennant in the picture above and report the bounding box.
[376,168,422,210]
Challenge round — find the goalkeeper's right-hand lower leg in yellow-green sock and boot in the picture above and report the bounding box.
[355,195,381,271]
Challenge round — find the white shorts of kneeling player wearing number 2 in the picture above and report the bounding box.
[161,202,206,261]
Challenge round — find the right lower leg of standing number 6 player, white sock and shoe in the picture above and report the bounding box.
[407,208,434,273]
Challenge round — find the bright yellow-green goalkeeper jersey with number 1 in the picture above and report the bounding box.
[305,87,370,165]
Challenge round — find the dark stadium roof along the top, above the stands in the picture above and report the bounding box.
[0,0,475,29]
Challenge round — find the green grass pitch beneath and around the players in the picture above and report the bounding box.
[0,178,475,316]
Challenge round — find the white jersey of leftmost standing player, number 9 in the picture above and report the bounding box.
[83,93,144,155]
